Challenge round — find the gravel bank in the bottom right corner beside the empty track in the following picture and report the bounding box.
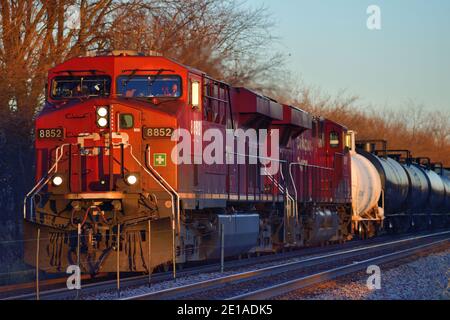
[279,249,450,300]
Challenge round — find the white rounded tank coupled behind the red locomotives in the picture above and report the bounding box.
[351,153,382,216]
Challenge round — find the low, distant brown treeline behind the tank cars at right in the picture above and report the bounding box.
[279,87,450,167]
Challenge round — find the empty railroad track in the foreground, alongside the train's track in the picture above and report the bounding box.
[122,232,450,300]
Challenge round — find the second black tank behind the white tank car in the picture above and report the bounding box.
[403,163,430,213]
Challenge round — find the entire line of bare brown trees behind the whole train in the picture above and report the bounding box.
[0,0,450,227]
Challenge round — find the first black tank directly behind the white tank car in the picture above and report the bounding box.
[358,150,409,216]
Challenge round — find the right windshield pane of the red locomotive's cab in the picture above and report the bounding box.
[117,75,181,98]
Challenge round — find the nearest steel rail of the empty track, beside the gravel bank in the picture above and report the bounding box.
[226,239,450,300]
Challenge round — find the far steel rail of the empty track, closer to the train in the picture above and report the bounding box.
[121,231,450,300]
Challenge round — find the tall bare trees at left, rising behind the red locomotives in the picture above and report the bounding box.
[0,0,282,235]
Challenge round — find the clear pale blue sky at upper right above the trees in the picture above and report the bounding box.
[248,0,450,110]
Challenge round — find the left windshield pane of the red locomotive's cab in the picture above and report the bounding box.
[51,76,111,99]
